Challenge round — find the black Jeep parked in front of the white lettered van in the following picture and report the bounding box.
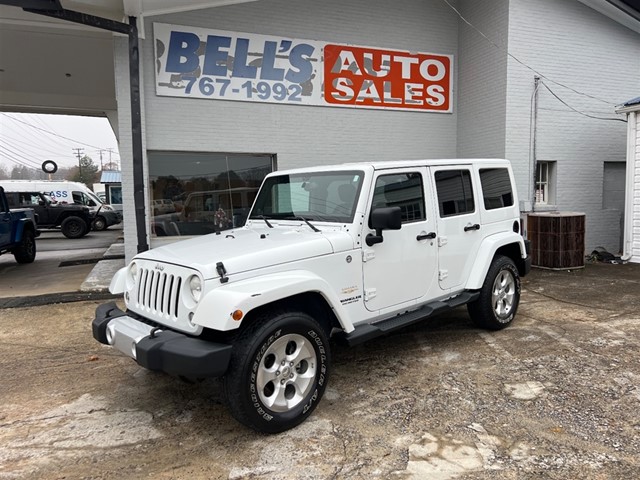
[5,192,93,238]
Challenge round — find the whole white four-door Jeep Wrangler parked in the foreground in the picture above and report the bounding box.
[92,160,531,433]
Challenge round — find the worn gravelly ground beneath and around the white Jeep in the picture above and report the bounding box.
[0,264,640,480]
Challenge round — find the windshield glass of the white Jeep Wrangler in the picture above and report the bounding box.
[249,171,364,222]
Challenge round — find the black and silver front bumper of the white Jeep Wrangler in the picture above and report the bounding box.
[91,302,232,378]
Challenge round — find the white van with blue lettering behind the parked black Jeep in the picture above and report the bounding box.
[2,180,122,230]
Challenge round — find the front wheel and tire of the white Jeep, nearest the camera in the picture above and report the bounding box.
[223,311,331,433]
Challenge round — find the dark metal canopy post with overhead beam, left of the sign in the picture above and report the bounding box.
[18,5,149,253]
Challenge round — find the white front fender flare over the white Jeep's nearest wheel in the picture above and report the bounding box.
[192,270,354,333]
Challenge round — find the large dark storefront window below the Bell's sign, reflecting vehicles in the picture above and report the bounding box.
[148,152,274,236]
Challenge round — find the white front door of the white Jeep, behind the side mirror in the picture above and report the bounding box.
[363,168,437,311]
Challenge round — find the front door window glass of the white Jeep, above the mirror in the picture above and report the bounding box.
[372,172,426,223]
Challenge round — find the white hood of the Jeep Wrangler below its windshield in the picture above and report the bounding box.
[135,226,353,279]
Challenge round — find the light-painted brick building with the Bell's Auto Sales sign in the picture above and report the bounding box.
[107,0,640,255]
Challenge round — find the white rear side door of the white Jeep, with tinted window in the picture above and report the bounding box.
[432,164,484,292]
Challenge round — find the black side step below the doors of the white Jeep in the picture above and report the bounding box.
[342,292,480,346]
